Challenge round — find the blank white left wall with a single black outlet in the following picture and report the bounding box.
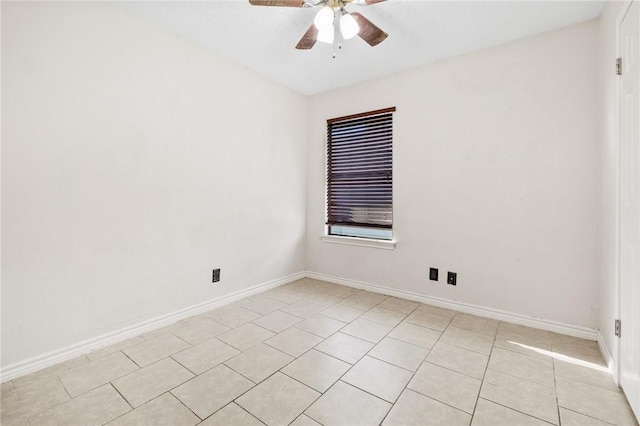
[2,2,307,367]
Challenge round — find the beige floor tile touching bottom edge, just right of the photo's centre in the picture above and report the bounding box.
[305,381,391,426]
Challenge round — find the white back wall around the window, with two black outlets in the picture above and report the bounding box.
[307,21,600,328]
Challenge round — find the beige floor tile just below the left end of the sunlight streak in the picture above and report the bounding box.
[489,348,555,386]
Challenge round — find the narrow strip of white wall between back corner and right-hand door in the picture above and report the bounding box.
[597,1,623,372]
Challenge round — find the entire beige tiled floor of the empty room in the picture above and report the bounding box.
[1,279,637,426]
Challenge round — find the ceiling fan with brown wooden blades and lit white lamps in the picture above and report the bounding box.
[249,0,389,50]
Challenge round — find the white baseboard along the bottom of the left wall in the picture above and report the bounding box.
[0,271,306,383]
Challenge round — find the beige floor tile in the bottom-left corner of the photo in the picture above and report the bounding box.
[0,375,69,424]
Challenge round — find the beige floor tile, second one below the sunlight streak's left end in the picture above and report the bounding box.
[480,368,558,425]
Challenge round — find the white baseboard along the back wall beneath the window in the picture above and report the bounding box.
[307,271,597,340]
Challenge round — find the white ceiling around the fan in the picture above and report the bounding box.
[119,0,605,95]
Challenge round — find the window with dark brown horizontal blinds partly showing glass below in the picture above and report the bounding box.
[327,107,395,240]
